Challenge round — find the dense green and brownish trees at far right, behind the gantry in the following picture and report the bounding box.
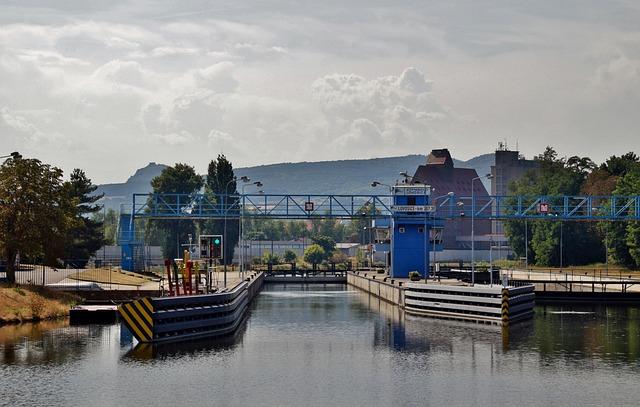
[504,147,640,268]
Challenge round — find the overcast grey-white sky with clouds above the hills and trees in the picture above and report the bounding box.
[0,0,640,183]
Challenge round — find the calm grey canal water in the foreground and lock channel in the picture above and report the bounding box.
[0,285,640,406]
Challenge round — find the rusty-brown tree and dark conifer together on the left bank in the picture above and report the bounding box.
[0,158,103,283]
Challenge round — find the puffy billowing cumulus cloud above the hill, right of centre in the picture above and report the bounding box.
[312,67,449,154]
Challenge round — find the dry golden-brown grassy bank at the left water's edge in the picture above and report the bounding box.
[0,285,79,325]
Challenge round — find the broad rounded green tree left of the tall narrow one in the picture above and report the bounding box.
[149,163,204,258]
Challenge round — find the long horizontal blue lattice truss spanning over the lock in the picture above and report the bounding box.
[132,194,640,221]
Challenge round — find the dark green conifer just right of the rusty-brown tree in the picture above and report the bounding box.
[63,168,104,268]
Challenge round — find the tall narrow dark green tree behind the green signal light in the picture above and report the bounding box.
[202,154,240,264]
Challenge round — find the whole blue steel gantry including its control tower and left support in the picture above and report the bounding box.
[119,192,640,277]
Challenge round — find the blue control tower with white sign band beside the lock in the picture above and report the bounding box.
[391,184,443,278]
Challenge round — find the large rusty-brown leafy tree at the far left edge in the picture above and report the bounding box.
[0,159,74,283]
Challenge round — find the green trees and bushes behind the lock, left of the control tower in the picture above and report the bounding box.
[145,154,373,263]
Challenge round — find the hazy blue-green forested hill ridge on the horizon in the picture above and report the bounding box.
[97,154,494,209]
